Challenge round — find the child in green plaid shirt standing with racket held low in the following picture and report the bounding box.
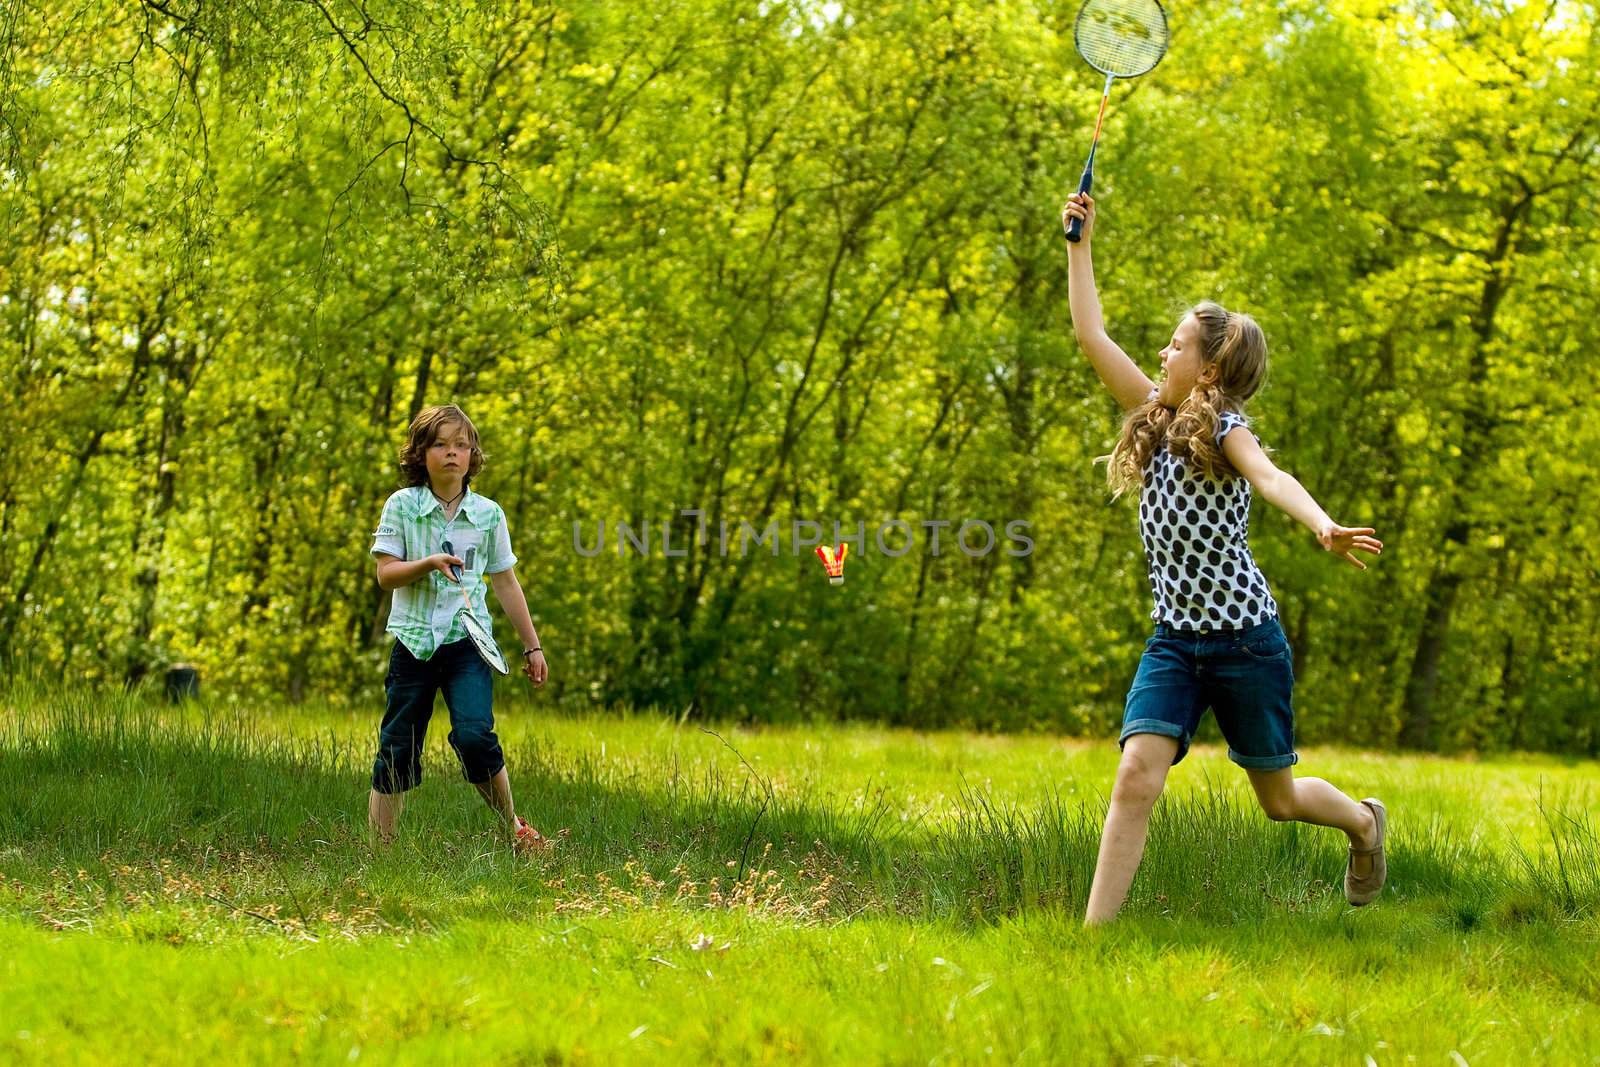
[366,405,549,851]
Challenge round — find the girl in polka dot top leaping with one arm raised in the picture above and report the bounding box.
[1061,194,1387,925]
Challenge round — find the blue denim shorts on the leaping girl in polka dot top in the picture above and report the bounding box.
[1117,619,1299,771]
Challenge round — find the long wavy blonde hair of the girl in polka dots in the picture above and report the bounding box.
[1101,301,1267,498]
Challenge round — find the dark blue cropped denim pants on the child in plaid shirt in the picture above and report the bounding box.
[373,640,506,793]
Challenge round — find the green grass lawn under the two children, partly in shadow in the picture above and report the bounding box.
[0,685,1600,1064]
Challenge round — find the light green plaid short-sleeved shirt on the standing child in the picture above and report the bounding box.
[370,485,517,659]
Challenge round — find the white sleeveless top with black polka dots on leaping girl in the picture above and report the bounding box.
[1139,404,1278,630]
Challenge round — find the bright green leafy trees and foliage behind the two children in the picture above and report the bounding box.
[0,0,1600,753]
